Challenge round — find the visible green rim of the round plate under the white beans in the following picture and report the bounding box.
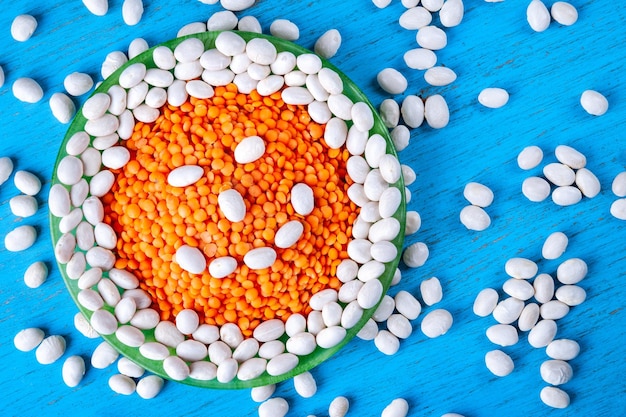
[50,32,406,389]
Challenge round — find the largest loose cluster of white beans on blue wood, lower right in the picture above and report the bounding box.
[473,232,587,408]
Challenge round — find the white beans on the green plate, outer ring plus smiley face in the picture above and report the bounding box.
[49,31,402,383]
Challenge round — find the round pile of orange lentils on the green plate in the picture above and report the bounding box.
[103,84,358,337]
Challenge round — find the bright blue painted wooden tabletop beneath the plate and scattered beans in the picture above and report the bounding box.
[0,0,626,417]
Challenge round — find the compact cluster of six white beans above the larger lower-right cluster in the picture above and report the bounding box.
[517,145,601,206]
